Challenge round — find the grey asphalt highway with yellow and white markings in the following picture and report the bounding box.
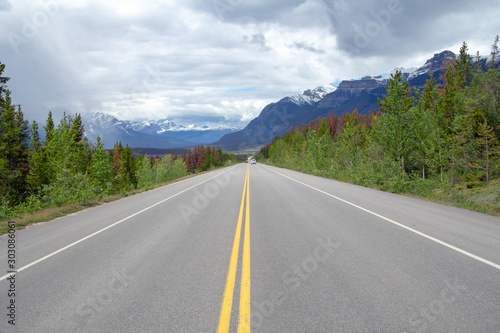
[0,164,500,333]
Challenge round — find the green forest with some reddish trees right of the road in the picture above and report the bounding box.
[259,40,500,213]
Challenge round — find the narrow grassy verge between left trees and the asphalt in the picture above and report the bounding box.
[0,166,237,235]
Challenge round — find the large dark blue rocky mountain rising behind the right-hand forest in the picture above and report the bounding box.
[214,51,456,151]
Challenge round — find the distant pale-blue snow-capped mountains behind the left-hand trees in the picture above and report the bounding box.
[82,112,238,148]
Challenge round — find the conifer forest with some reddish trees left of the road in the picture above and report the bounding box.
[0,63,235,219]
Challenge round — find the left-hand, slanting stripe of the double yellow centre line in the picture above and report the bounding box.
[217,165,249,333]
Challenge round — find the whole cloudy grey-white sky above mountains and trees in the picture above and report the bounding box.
[0,0,500,126]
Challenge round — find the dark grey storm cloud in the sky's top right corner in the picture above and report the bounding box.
[321,0,500,57]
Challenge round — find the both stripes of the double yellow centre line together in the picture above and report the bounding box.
[217,165,250,333]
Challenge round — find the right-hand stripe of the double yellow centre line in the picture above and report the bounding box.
[238,165,250,333]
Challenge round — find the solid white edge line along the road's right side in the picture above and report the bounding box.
[269,169,500,269]
